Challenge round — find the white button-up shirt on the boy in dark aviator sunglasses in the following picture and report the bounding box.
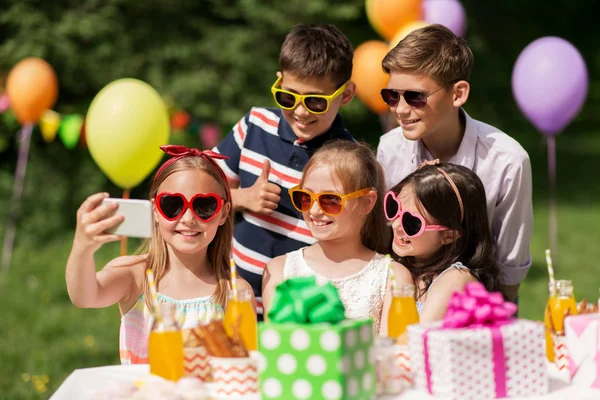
[377,111,533,285]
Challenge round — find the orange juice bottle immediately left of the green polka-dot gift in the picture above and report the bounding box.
[223,288,258,350]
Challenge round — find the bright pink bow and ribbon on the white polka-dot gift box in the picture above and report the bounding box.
[423,282,517,397]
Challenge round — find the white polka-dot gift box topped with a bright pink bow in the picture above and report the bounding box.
[408,283,548,400]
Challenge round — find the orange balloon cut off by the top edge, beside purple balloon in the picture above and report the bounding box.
[365,0,423,41]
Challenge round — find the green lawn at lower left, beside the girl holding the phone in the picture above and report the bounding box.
[0,232,142,400]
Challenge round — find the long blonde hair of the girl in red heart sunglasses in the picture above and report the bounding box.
[138,156,233,309]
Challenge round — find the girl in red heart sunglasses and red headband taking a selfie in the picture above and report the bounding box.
[66,146,254,364]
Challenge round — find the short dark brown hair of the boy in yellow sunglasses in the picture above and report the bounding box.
[279,24,354,87]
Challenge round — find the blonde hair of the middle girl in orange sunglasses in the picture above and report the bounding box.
[300,140,391,254]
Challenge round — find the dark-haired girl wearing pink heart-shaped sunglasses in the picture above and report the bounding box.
[383,160,500,322]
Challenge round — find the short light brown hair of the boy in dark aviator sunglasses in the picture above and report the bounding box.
[381,24,474,85]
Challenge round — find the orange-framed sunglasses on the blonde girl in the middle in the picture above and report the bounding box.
[288,186,373,215]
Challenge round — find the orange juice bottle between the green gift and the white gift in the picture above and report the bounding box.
[388,285,419,339]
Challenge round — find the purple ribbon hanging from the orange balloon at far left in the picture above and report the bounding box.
[2,123,33,271]
